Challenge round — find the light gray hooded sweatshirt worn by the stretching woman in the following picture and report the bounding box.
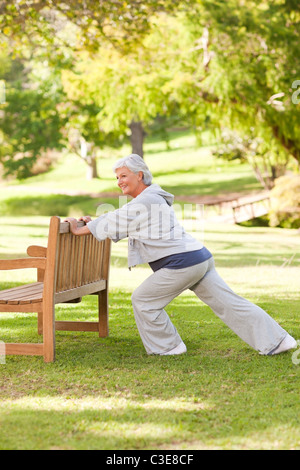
[87,184,203,268]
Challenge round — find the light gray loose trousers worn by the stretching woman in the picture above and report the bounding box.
[132,258,287,354]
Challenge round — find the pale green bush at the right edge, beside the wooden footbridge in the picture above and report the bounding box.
[270,174,300,228]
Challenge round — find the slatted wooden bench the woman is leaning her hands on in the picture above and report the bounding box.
[0,217,111,362]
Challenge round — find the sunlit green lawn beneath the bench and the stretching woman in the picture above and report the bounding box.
[0,131,300,450]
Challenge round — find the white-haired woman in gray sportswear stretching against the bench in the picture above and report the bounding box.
[66,154,297,355]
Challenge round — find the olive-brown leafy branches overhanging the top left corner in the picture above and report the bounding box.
[0,0,191,51]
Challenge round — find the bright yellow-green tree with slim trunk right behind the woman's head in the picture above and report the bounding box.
[62,14,197,156]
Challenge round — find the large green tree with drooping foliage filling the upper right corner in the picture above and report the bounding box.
[177,0,300,169]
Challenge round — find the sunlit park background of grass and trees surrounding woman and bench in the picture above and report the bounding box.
[0,0,300,450]
